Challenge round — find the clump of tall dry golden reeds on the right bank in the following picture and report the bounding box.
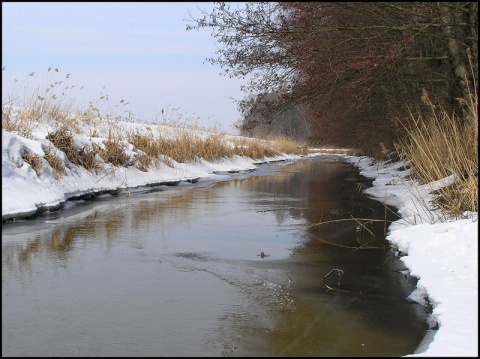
[396,85,478,218]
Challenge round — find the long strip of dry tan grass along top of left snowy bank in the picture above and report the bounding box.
[2,68,308,177]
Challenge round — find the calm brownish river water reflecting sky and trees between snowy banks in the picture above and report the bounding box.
[2,157,427,356]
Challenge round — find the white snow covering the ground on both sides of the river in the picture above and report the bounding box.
[2,129,478,357]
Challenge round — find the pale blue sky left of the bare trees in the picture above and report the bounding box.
[2,2,247,132]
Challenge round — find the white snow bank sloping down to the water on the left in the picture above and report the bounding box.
[2,130,308,221]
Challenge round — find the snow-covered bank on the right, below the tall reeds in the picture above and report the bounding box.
[346,156,478,357]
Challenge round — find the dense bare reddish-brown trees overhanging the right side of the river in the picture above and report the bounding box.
[187,2,478,156]
